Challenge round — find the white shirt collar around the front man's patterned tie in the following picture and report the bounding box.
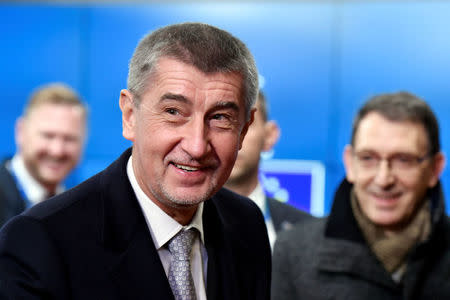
[127,156,204,250]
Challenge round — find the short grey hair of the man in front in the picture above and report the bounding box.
[127,23,258,118]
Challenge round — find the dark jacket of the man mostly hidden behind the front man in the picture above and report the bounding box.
[266,197,313,232]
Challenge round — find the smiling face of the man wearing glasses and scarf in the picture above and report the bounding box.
[344,112,444,230]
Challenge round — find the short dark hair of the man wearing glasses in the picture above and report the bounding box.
[351,92,440,155]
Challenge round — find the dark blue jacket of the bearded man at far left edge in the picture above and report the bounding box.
[0,160,25,227]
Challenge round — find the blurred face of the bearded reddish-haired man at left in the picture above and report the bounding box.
[16,103,86,190]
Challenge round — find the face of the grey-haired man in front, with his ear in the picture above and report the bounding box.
[120,58,253,219]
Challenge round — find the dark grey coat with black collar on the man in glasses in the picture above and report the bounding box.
[272,181,450,300]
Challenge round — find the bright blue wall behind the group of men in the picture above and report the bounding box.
[0,1,450,211]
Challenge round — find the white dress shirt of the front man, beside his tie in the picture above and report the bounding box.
[127,156,208,300]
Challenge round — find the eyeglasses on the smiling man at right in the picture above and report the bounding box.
[353,152,431,171]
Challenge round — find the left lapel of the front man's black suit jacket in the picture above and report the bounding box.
[100,150,173,299]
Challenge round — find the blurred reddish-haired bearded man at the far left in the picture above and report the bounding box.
[0,83,86,225]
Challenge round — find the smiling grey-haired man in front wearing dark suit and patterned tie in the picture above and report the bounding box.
[0,23,271,300]
